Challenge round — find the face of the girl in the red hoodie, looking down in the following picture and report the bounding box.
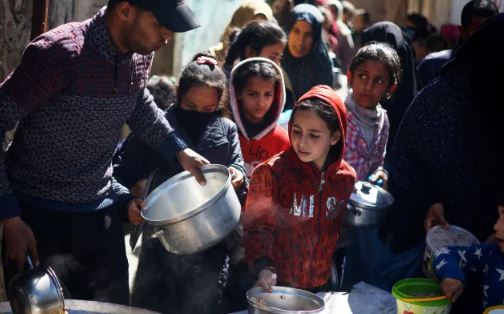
[290,110,341,169]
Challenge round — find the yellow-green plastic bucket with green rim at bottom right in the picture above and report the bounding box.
[392,278,451,314]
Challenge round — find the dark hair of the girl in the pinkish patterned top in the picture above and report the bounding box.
[349,42,401,85]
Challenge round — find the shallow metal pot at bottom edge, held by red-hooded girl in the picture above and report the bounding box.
[246,286,325,314]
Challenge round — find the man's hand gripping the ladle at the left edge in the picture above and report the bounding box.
[3,217,40,271]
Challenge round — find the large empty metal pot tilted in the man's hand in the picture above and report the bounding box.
[141,164,241,254]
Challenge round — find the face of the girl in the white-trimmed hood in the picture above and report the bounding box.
[237,76,275,123]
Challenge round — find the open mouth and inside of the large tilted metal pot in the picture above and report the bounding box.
[141,164,231,225]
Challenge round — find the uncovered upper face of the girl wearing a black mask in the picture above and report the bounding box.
[180,85,219,112]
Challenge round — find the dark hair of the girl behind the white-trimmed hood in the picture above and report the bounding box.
[224,20,287,68]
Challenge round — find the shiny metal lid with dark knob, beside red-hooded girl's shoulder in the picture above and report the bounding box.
[350,181,394,209]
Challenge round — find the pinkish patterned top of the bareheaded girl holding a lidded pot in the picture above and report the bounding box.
[343,110,390,180]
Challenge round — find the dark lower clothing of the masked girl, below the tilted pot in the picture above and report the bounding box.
[131,226,229,314]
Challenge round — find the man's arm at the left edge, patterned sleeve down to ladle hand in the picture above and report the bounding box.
[0,34,73,269]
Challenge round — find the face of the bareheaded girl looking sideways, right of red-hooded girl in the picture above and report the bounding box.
[350,60,391,109]
